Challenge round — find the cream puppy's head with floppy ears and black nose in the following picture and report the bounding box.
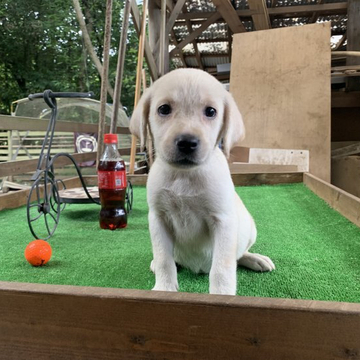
[130,69,245,168]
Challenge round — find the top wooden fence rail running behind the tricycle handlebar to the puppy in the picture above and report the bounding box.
[0,115,130,134]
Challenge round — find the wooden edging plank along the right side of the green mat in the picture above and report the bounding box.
[304,173,360,226]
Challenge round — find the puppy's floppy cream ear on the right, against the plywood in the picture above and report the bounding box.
[222,92,245,158]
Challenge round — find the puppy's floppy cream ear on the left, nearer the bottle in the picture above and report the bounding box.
[130,87,151,149]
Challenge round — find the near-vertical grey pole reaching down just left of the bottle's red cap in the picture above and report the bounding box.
[96,0,112,164]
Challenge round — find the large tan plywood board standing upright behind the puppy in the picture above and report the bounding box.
[230,23,331,181]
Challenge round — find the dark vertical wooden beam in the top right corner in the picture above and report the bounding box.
[346,0,360,91]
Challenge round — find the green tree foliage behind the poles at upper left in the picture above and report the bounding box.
[0,0,138,113]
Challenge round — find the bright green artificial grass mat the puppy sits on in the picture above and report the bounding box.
[0,184,360,302]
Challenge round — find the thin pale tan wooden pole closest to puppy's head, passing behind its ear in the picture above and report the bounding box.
[129,0,148,174]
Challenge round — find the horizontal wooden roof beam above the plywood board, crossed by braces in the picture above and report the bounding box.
[178,2,348,21]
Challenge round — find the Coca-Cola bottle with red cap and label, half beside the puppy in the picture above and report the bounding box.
[98,134,127,230]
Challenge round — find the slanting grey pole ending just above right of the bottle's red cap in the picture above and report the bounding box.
[110,0,131,133]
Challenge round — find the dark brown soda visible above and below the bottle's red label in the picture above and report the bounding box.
[98,160,127,230]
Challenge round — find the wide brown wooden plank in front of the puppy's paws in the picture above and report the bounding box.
[0,282,360,360]
